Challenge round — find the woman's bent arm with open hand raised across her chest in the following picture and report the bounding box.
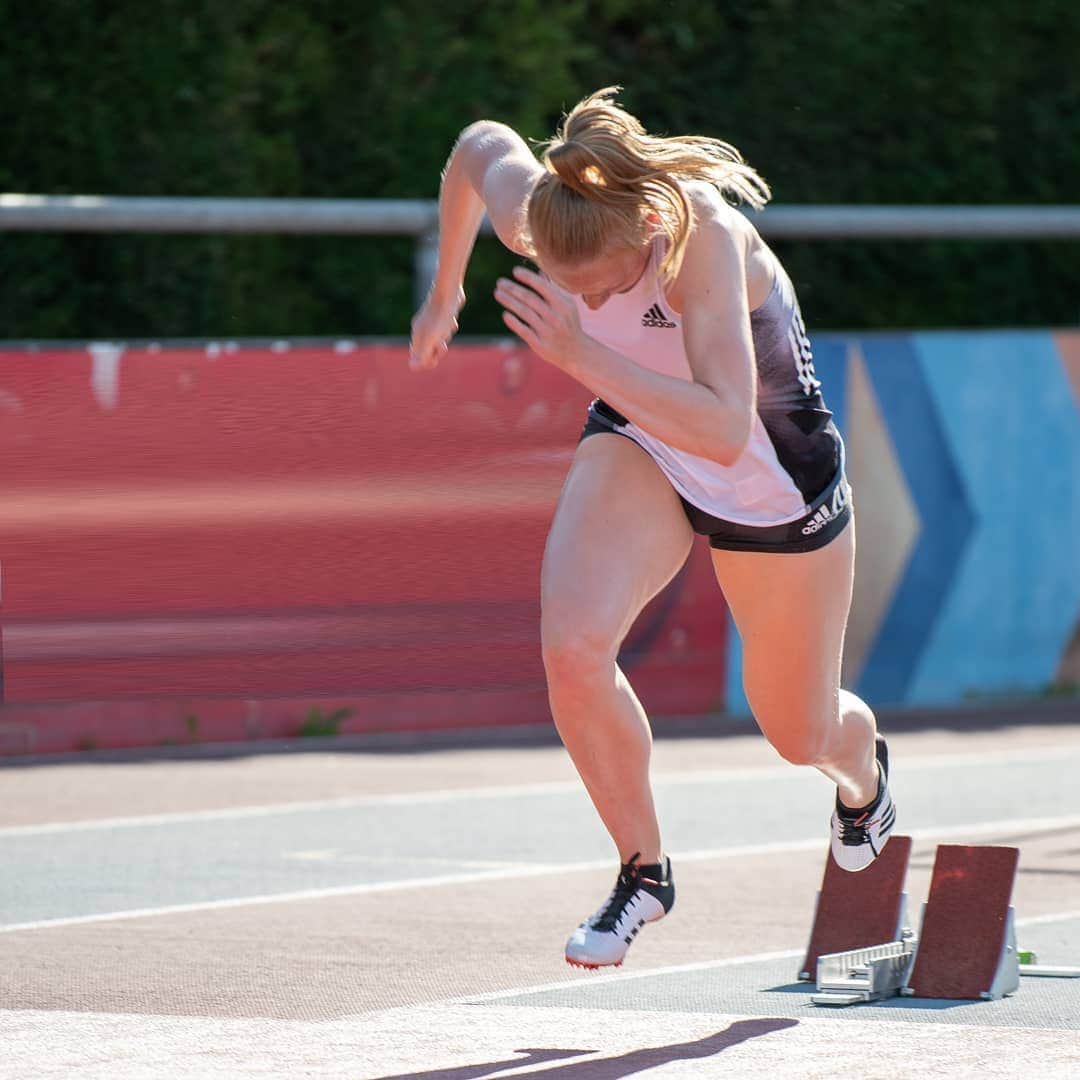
[495,210,756,465]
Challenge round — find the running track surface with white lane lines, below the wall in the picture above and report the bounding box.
[0,705,1080,1080]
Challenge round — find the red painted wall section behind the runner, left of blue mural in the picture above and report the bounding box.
[0,343,726,753]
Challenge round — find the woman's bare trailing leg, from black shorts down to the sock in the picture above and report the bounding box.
[712,519,878,808]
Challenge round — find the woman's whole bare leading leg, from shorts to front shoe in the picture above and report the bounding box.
[541,433,693,863]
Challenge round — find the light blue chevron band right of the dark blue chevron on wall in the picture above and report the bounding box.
[905,333,1080,703]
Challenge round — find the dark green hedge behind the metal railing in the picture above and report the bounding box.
[0,0,1080,339]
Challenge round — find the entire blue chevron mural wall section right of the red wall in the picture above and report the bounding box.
[728,330,1080,713]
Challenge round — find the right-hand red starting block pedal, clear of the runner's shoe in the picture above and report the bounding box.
[904,843,1020,1000]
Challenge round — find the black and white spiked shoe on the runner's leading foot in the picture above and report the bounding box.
[566,854,675,969]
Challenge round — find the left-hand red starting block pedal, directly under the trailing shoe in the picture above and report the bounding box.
[799,836,912,983]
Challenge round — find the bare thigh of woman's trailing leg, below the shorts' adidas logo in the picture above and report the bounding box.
[713,521,855,735]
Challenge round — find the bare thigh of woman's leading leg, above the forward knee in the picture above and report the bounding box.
[541,433,693,643]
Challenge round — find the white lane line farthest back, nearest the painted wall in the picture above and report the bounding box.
[0,746,1080,840]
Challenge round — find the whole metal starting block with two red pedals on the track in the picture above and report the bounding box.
[799,836,1080,1007]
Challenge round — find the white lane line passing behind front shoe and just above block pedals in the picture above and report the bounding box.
[6,814,1080,934]
